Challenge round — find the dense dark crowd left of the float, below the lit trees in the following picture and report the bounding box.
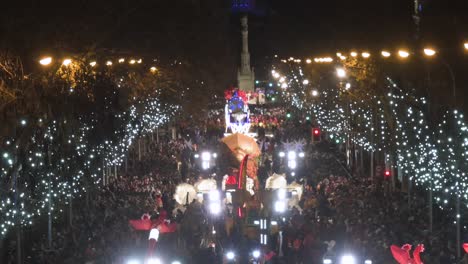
[27,137,183,264]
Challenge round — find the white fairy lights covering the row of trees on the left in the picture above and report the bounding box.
[0,59,180,235]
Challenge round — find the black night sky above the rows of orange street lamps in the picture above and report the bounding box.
[0,0,468,107]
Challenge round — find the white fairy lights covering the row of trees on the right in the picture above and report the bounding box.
[272,56,468,213]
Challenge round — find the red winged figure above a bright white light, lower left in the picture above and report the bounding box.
[129,210,177,259]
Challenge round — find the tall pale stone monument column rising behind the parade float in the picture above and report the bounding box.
[237,15,255,92]
